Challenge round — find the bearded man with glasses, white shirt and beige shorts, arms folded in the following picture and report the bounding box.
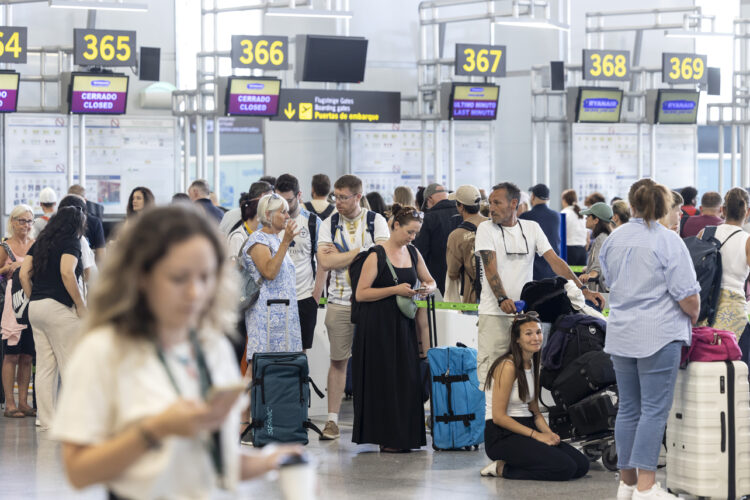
[318,174,390,439]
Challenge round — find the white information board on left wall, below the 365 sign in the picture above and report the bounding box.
[4,113,175,214]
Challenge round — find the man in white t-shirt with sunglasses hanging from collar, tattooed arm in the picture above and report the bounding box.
[474,182,604,388]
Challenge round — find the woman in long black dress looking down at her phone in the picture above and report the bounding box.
[352,204,436,453]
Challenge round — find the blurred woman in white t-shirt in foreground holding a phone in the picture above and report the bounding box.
[53,205,299,500]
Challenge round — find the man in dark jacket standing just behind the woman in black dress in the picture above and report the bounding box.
[414,183,461,294]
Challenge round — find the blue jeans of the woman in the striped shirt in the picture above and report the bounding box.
[612,342,683,471]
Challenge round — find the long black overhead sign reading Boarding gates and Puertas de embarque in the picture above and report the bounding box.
[271,89,401,123]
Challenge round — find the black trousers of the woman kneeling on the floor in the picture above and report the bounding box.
[484,417,589,481]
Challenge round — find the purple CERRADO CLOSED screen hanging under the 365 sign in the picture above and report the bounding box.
[70,74,128,115]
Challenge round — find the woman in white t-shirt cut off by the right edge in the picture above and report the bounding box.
[698,188,750,339]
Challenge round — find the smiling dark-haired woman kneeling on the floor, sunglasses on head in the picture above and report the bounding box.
[481,311,589,481]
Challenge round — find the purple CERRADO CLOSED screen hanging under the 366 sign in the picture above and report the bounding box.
[227,78,281,116]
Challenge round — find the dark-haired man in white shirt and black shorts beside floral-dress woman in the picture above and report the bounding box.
[275,174,328,350]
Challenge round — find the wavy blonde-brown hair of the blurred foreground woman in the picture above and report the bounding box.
[85,203,239,340]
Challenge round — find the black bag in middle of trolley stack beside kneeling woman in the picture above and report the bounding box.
[552,351,617,407]
